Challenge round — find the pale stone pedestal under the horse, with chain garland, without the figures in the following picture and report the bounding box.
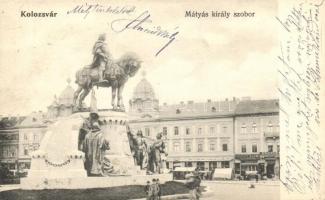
[21,111,150,189]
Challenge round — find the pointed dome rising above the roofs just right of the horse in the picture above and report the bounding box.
[133,72,155,100]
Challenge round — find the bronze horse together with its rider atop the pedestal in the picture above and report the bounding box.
[73,34,141,111]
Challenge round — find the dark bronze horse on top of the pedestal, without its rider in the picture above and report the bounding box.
[73,53,141,111]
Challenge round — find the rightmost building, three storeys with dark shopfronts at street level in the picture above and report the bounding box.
[235,100,280,177]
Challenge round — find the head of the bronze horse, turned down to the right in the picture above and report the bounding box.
[117,53,142,77]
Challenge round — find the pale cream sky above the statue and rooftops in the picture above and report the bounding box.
[0,0,279,115]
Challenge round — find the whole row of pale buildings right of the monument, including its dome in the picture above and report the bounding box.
[129,74,279,177]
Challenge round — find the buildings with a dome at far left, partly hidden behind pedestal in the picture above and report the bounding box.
[0,80,74,173]
